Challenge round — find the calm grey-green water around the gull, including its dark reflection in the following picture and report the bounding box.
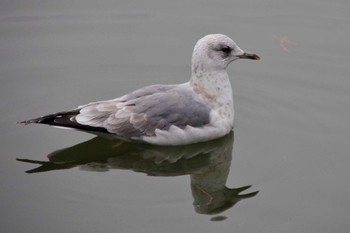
[0,0,350,233]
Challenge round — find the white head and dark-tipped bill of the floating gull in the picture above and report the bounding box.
[192,34,260,73]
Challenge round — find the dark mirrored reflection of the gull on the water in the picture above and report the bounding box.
[17,133,258,221]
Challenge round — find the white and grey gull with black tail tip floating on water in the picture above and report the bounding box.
[19,34,260,145]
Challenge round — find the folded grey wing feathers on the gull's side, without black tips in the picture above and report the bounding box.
[76,85,210,138]
